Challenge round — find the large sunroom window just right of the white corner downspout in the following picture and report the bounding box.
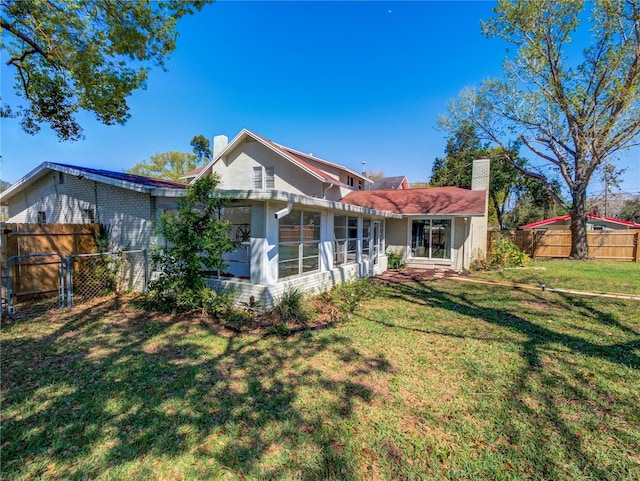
[278,210,320,279]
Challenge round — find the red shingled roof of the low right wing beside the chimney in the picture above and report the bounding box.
[340,187,486,215]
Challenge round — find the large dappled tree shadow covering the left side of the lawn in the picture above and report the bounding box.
[1,294,389,480]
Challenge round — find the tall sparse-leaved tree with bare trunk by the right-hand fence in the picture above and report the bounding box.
[439,0,640,259]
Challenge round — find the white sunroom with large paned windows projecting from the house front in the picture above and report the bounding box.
[208,191,400,309]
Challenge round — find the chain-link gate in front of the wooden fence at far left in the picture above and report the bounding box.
[0,253,65,318]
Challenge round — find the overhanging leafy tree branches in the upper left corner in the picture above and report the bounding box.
[0,0,206,140]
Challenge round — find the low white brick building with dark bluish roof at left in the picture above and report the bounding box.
[0,162,186,250]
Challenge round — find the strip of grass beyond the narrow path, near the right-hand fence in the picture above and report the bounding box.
[472,259,640,295]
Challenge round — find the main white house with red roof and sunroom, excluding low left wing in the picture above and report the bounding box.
[193,130,489,307]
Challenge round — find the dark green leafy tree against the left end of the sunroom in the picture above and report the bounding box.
[149,175,234,311]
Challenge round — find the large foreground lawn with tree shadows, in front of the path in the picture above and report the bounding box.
[0,264,640,480]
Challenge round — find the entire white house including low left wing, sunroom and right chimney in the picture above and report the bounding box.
[0,129,489,309]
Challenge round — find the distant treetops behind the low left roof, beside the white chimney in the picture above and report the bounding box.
[125,135,211,181]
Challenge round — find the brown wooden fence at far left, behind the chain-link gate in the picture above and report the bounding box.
[0,224,100,295]
